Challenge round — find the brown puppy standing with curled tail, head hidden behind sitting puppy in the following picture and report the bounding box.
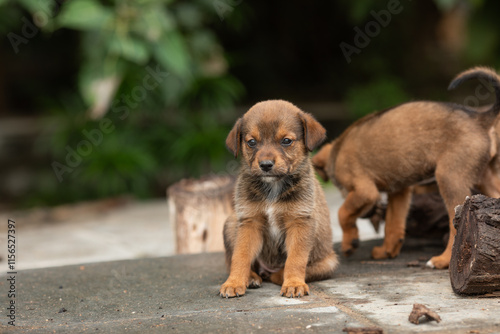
[313,68,500,268]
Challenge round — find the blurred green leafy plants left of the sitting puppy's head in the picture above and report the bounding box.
[6,0,244,205]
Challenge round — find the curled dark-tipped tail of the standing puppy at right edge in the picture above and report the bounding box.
[448,67,500,121]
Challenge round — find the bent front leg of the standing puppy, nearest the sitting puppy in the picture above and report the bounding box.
[339,180,380,256]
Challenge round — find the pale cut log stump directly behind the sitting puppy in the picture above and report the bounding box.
[167,176,235,254]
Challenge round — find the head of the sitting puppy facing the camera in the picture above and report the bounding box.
[226,100,326,181]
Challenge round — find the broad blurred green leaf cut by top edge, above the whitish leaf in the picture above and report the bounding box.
[57,0,114,30]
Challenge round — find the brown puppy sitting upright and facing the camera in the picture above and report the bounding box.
[220,101,338,298]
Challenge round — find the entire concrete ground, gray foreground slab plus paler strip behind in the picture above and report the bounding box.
[0,188,500,333]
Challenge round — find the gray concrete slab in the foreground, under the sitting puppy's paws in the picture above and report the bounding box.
[0,240,500,333]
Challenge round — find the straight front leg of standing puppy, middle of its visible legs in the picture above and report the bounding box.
[372,187,411,260]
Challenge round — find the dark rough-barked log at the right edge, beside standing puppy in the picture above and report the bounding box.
[450,195,500,295]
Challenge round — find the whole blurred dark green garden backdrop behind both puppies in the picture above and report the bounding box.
[0,0,500,209]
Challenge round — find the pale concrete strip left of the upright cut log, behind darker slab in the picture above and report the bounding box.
[0,200,175,270]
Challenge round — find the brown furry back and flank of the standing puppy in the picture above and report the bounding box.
[333,101,489,189]
